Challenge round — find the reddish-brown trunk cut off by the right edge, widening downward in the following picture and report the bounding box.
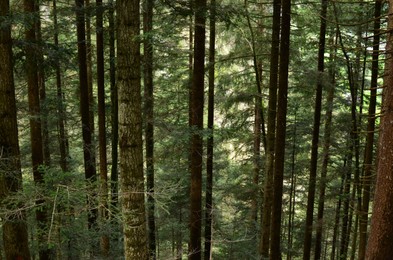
[366,0,393,260]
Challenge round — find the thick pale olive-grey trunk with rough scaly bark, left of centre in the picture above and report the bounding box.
[117,0,148,259]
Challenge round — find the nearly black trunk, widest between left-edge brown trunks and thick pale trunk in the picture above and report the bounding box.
[75,0,97,231]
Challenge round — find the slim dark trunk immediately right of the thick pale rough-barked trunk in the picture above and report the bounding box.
[143,0,156,259]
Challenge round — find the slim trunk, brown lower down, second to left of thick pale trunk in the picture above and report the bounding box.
[96,0,109,254]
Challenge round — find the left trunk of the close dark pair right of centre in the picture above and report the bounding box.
[259,0,281,258]
